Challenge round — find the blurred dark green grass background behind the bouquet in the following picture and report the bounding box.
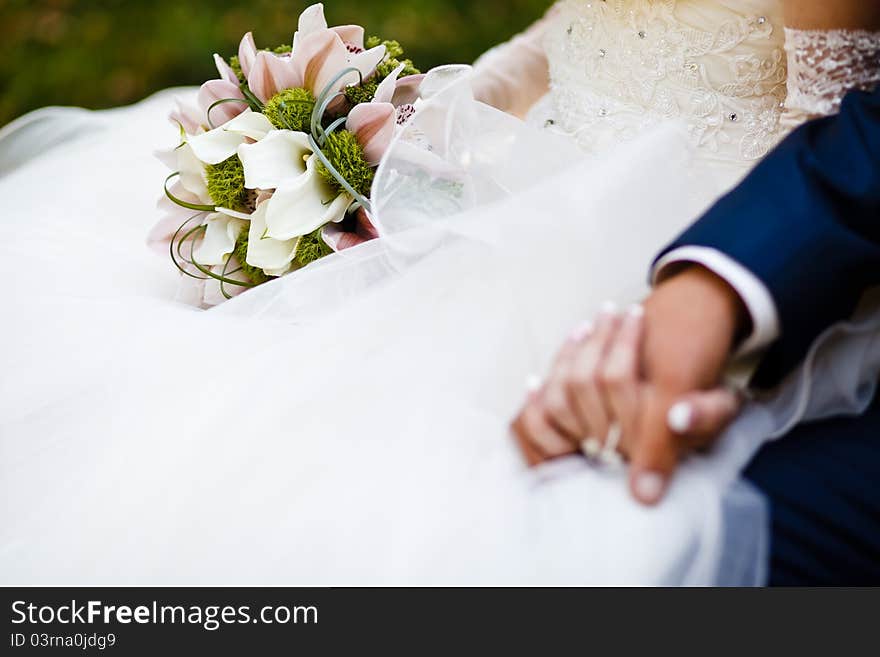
[0,0,550,125]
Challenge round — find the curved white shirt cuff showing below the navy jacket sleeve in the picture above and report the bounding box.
[651,246,779,357]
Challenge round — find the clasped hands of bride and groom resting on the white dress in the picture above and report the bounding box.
[513,267,747,504]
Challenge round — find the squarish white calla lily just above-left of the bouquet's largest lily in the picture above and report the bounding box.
[238,130,312,189]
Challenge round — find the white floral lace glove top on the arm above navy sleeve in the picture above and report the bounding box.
[785,28,880,118]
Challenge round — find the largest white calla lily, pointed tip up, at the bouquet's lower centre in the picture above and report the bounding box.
[266,155,352,240]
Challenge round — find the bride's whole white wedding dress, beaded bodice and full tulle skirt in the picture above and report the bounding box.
[0,0,877,584]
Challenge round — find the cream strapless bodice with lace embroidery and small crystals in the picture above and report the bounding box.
[537,0,786,164]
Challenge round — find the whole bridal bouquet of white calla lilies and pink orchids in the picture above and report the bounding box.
[149,4,423,305]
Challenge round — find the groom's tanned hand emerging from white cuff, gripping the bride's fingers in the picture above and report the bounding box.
[624,266,748,504]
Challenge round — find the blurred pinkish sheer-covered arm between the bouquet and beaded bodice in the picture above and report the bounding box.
[473,5,557,117]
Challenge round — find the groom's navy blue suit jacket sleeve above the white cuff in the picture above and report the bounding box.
[661,90,880,386]
